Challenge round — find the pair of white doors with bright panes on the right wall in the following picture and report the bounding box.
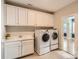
[61,15,78,55]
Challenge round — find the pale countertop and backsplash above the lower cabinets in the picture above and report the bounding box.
[4,32,34,42]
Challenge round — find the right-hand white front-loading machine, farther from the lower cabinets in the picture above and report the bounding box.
[48,29,58,50]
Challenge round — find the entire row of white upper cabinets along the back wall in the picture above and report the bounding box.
[6,5,53,27]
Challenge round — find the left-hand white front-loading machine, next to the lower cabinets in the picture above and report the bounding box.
[35,30,50,55]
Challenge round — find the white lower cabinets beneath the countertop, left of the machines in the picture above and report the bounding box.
[4,40,34,59]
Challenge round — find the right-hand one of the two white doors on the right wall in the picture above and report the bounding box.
[68,13,78,55]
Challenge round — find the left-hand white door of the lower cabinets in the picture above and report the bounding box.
[5,42,21,59]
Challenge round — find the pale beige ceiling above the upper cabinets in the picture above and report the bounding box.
[7,0,77,12]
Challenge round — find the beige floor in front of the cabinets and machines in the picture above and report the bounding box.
[21,51,74,59]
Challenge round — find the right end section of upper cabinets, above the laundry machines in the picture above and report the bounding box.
[36,12,53,27]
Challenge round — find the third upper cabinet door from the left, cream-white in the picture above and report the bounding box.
[28,10,36,26]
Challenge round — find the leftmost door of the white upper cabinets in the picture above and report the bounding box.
[6,5,18,25]
